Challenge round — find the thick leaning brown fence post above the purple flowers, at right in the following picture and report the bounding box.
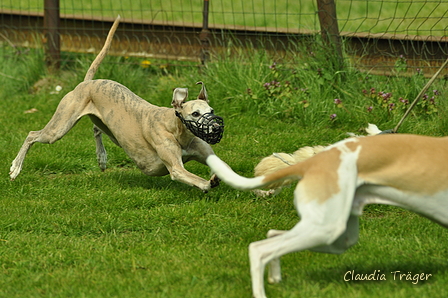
[317,0,343,66]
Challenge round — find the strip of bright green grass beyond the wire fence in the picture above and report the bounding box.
[2,0,447,36]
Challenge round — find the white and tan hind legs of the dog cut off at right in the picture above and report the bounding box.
[249,150,358,298]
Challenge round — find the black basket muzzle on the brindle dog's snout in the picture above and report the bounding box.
[176,111,224,145]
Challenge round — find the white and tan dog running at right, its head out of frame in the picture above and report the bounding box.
[207,134,448,298]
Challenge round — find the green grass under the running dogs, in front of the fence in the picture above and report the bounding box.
[0,44,448,298]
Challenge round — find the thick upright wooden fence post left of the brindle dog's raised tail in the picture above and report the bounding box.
[44,0,61,70]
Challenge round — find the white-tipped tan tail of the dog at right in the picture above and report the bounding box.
[206,155,303,190]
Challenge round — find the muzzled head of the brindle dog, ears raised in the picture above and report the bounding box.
[171,82,224,145]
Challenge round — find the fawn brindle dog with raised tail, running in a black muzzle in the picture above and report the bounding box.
[10,17,223,192]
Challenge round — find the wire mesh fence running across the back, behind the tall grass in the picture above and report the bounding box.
[0,0,448,76]
